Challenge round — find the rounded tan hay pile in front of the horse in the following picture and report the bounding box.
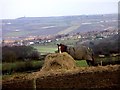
[41,52,76,71]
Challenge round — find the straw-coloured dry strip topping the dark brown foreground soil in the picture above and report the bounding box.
[26,65,120,79]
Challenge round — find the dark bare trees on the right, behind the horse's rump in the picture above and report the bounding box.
[89,35,120,56]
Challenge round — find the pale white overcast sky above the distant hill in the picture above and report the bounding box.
[0,0,119,19]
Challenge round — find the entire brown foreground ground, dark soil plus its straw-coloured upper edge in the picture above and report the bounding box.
[2,65,120,90]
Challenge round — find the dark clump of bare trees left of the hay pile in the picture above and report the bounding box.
[2,46,40,62]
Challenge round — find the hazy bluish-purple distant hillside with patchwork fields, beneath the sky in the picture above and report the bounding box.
[2,14,117,38]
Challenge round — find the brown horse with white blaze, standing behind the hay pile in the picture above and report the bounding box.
[57,44,94,66]
